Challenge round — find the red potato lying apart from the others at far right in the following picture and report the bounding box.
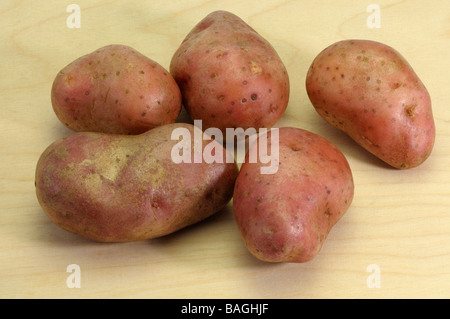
[306,40,435,169]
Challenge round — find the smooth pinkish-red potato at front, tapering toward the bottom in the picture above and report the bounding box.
[233,127,354,263]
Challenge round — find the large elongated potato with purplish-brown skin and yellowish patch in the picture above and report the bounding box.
[35,123,238,242]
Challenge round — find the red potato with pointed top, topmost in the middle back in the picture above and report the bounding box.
[170,11,289,136]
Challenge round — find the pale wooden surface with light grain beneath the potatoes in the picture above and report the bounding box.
[0,0,450,298]
